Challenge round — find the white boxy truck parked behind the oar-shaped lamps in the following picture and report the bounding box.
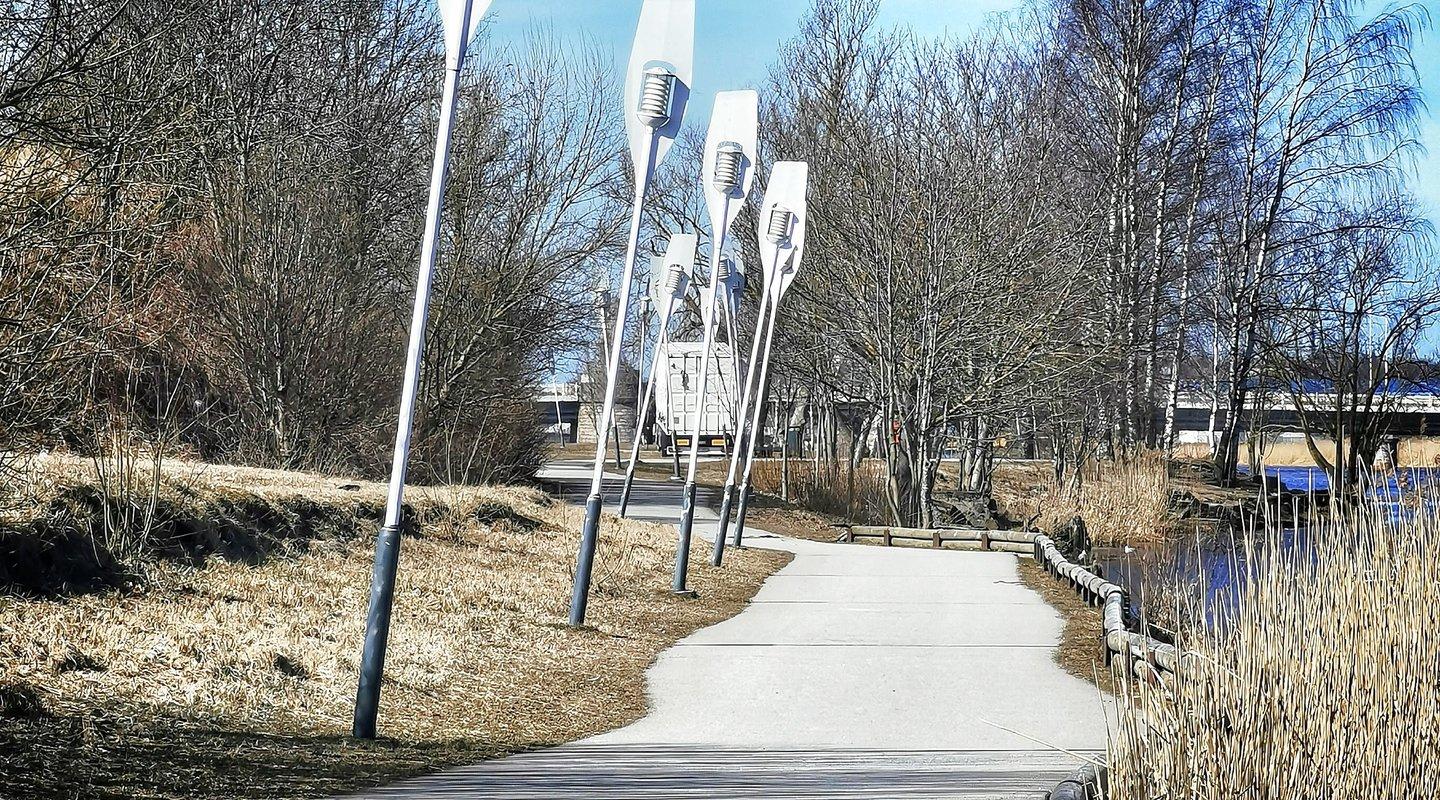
[655,341,744,455]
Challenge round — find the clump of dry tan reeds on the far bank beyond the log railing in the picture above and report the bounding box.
[995,452,1176,544]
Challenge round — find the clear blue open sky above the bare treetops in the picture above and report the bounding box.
[490,0,1440,227]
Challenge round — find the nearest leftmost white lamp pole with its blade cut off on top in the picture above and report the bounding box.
[351,0,490,740]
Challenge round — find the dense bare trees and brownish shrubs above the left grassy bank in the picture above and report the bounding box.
[0,0,624,479]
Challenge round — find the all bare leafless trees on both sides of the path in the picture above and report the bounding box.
[0,0,1440,524]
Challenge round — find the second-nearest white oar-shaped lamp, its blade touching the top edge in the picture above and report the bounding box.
[570,0,696,624]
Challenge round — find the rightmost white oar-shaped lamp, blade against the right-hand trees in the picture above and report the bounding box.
[711,161,809,565]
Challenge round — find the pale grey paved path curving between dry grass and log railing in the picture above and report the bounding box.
[345,465,1106,800]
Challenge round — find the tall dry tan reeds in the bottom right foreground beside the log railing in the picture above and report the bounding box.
[1109,492,1440,800]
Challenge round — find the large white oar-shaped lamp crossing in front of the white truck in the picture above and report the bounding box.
[672,89,759,593]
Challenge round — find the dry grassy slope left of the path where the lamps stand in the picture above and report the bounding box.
[0,459,785,800]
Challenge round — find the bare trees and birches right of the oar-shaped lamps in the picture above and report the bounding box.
[763,0,1440,524]
